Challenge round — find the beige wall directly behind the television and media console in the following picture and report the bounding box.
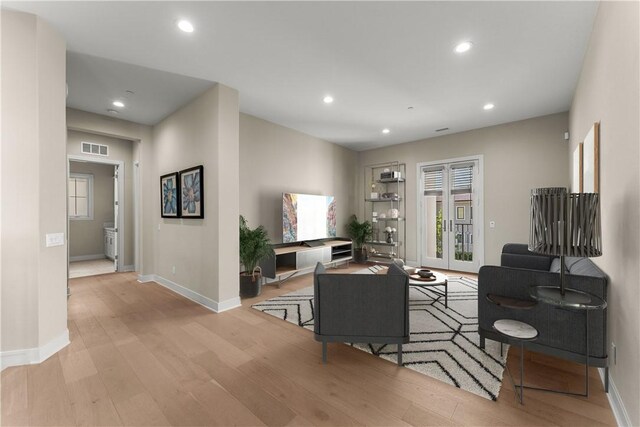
[240,114,357,243]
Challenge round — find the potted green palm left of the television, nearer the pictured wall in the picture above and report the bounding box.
[240,215,273,298]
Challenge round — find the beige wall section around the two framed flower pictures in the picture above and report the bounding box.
[152,84,240,309]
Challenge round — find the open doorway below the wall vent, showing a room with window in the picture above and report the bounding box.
[67,155,124,278]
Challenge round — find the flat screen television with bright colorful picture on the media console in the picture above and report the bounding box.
[282,193,336,243]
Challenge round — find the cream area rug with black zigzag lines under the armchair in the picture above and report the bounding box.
[252,266,508,400]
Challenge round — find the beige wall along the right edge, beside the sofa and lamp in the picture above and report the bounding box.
[567,2,640,426]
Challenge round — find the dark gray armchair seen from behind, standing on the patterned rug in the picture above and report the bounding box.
[313,263,409,366]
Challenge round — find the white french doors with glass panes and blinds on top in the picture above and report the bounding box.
[418,158,484,272]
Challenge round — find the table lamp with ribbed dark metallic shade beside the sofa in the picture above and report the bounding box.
[529,187,602,299]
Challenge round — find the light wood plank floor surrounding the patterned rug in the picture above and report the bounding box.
[1,266,615,426]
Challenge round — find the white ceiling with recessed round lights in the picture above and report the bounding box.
[3,1,598,150]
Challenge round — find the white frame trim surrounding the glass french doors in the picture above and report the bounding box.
[416,154,485,273]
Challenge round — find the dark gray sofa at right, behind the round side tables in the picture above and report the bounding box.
[478,243,608,368]
